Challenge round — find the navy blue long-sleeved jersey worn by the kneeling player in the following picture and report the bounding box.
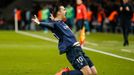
[40,21,77,54]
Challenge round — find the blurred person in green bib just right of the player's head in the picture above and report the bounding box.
[66,4,75,30]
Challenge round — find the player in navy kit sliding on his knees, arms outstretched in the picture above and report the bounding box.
[32,6,97,75]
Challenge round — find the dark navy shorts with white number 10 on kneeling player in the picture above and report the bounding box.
[66,46,93,70]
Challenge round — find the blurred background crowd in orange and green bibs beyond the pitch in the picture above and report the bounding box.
[0,0,134,34]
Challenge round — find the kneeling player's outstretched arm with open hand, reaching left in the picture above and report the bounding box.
[32,15,54,29]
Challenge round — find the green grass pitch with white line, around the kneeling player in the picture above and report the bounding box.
[0,31,134,75]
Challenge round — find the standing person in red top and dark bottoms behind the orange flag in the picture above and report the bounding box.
[76,0,88,31]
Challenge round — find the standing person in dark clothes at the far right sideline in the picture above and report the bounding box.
[119,0,133,46]
